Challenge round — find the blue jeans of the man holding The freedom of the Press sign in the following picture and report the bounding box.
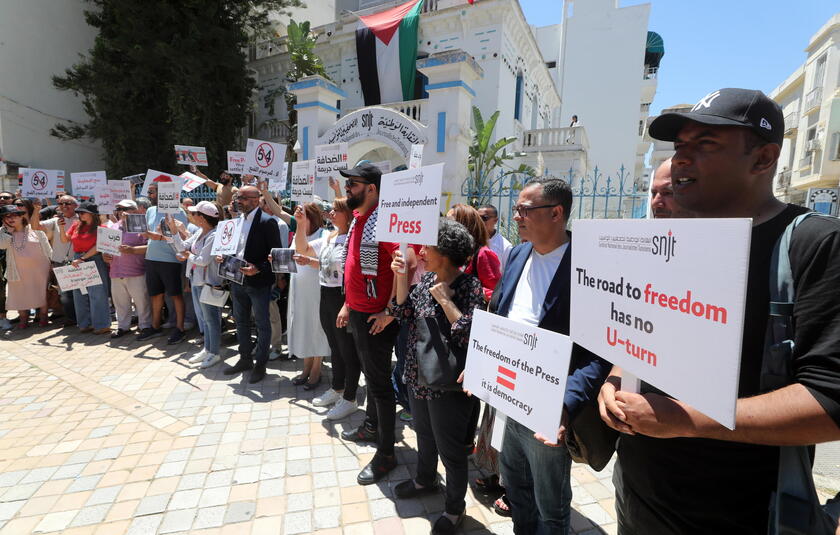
[499,418,572,535]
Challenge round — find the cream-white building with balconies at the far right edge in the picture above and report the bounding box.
[770,13,840,211]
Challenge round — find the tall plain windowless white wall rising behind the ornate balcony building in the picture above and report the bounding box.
[558,0,650,180]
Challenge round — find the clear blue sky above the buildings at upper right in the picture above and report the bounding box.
[519,0,840,115]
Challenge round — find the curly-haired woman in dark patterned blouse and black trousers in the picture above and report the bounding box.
[391,219,484,533]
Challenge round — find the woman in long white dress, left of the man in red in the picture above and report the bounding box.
[288,203,330,390]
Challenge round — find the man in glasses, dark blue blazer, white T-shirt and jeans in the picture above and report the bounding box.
[482,179,609,534]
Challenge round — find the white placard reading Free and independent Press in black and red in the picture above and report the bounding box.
[376,163,443,245]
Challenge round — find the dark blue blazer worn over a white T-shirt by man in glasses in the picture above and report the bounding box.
[490,238,612,421]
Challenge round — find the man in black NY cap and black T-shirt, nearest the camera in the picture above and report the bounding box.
[599,89,840,535]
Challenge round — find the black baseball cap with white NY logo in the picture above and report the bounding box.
[649,87,785,145]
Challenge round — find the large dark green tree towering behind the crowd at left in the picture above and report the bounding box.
[51,0,302,180]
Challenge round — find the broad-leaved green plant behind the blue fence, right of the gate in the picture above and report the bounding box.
[466,106,535,206]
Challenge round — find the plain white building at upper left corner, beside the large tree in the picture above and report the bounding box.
[0,0,104,190]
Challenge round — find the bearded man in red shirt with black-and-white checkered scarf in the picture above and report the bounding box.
[336,163,416,485]
